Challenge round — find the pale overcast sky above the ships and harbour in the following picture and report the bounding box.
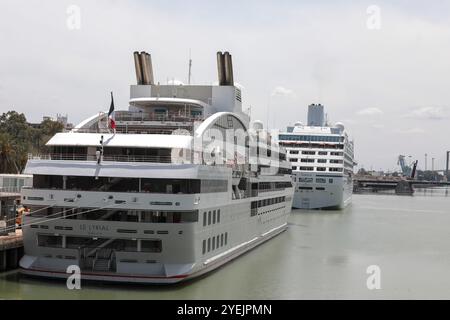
[0,0,450,171]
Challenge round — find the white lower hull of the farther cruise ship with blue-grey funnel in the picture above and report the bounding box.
[292,172,353,209]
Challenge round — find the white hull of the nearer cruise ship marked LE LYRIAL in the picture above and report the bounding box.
[20,171,293,284]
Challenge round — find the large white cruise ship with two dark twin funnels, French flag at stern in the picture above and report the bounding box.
[20,52,294,283]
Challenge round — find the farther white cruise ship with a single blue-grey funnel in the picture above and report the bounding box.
[279,104,355,209]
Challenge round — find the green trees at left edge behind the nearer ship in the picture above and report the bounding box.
[0,111,64,173]
